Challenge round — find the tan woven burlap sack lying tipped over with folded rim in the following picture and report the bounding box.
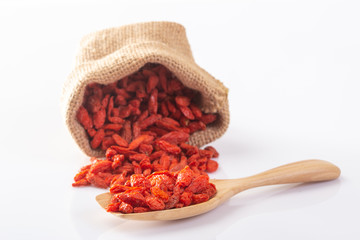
[61,22,229,157]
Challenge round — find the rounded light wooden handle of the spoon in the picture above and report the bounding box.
[239,160,340,191]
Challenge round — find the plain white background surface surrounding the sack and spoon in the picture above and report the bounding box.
[0,0,360,240]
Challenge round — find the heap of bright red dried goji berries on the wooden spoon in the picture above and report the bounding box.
[107,166,216,213]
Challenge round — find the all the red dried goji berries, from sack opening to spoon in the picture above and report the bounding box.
[73,64,218,212]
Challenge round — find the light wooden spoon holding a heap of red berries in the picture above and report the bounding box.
[96,160,340,220]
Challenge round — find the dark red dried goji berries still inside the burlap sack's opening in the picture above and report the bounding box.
[76,64,216,151]
